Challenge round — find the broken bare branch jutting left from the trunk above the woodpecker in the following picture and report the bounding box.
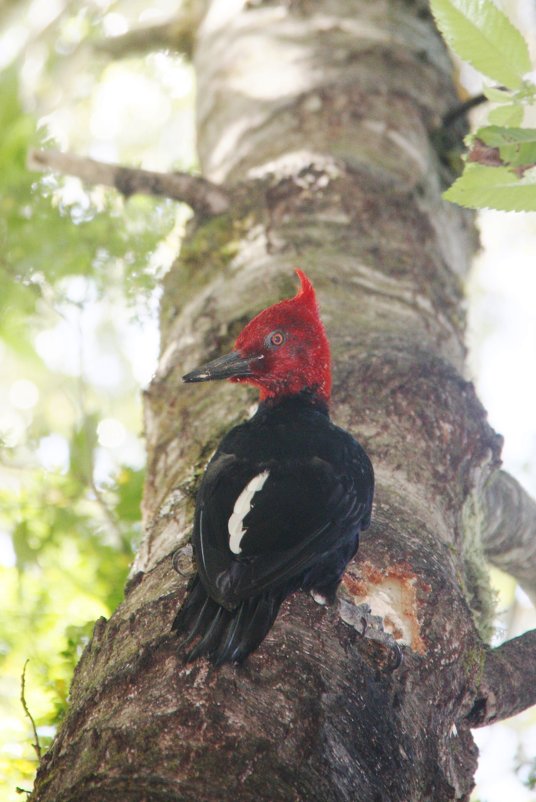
[28,150,230,217]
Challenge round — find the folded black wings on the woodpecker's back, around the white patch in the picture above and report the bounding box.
[193,444,373,609]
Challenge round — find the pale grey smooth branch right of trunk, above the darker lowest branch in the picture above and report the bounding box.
[483,471,536,605]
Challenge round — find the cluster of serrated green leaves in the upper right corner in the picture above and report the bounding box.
[431,0,536,211]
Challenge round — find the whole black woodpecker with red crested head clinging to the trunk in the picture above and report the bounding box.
[173,270,374,665]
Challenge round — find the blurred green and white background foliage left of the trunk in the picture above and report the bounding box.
[0,0,193,802]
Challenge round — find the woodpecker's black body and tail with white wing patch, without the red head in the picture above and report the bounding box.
[173,392,374,665]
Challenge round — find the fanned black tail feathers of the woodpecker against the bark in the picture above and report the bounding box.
[173,577,283,665]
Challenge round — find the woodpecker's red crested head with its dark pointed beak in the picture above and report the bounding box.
[184,270,331,403]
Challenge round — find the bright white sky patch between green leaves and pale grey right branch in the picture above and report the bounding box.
[468,216,536,497]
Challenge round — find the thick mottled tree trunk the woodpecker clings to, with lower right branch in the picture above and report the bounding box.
[32,0,536,802]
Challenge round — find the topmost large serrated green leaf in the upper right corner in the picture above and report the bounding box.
[431,0,531,89]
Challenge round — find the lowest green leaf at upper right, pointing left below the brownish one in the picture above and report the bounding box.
[443,164,536,212]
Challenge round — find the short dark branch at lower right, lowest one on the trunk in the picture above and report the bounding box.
[467,629,536,727]
